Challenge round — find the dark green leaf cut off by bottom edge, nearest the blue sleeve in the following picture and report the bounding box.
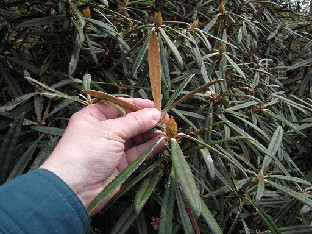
[111,204,138,234]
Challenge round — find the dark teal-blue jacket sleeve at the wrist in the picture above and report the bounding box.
[0,169,90,234]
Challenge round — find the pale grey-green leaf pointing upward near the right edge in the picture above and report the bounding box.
[261,126,284,170]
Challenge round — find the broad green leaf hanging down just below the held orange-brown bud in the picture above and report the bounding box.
[171,138,201,217]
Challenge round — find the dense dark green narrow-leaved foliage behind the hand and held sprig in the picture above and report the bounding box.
[0,0,312,233]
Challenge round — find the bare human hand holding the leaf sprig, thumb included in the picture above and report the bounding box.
[40,98,164,214]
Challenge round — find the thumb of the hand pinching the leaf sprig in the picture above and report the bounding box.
[111,108,161,140]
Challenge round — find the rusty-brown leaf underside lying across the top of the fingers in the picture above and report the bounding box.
[82,90,142,111]
